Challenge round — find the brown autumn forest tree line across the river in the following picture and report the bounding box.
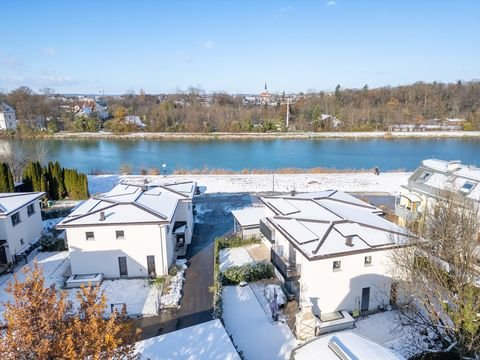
[0,81,480,133]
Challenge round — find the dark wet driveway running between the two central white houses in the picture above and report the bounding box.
[136,194,251,339]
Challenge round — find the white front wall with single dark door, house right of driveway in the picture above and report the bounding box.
[297,250,391,313]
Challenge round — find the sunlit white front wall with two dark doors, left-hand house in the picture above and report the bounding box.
[66,224,169,278]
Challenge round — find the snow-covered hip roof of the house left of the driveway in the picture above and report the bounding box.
[57,182,196,228]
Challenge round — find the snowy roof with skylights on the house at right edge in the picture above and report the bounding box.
[408,159,480,202]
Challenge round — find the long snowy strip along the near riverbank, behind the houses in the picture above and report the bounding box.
[88,172,411,194]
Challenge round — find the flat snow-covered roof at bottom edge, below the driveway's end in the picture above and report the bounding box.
[135,319,240,360]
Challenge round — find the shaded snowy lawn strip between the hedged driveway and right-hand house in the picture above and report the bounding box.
[223,286,297,360]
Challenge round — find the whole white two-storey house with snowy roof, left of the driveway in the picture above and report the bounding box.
[57,182,196,278]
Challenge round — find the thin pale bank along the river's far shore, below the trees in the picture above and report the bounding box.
[47,131,480,140]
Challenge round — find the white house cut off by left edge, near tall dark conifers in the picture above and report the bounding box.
[0,192,45,268]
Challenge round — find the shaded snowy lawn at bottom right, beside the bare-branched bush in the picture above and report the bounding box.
[352,311,436,359]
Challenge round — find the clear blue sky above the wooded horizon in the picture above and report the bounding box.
[0,0,480,94]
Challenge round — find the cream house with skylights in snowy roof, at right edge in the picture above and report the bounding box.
[395,159,480,221]
